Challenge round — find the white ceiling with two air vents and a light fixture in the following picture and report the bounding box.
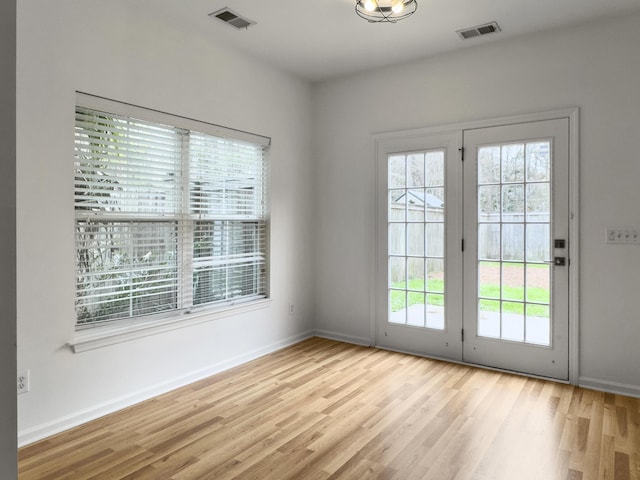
[141,0,640,81]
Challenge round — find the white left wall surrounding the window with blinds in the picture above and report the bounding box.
[15,0,313,443]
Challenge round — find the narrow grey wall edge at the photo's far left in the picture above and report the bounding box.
[0,0,18,472]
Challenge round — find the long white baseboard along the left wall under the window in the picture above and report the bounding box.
[18,331,314,447]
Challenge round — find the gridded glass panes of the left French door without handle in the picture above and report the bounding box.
[387,150,445,330]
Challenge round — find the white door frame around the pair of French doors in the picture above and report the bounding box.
[369,107,580,385]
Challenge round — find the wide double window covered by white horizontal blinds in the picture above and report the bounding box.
[74,95,269,328]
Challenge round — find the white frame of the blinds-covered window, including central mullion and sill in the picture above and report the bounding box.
[69,92,271,352]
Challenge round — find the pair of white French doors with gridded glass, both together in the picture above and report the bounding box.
[376,118,570,380]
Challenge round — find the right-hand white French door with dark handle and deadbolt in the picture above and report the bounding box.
[463,119,569,380]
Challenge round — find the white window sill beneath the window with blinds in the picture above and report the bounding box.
[67,298,271,353]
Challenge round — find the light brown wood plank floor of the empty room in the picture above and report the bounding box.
[19,338,640,480]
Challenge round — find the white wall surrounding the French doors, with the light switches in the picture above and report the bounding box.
[314,15,640,395]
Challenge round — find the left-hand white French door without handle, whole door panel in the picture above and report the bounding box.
[376,132,462,360]
